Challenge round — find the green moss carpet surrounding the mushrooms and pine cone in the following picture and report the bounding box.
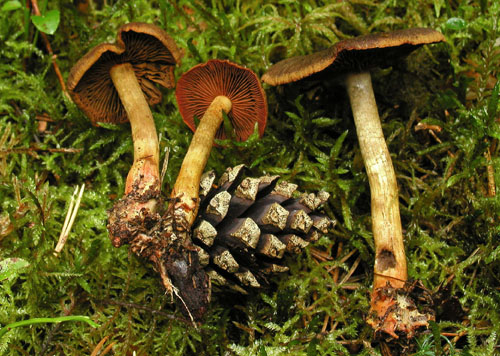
[0,0,500,355]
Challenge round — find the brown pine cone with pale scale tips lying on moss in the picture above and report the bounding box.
[192,165,333,293]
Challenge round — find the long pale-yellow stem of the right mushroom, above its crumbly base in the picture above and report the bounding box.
[346,72,408,290]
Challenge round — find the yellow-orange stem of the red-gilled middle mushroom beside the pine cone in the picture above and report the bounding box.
[171,95,232,227]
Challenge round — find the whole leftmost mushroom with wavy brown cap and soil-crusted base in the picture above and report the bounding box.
[67,23,181,247]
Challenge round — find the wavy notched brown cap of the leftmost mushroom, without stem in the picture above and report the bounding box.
[67,23,181,124]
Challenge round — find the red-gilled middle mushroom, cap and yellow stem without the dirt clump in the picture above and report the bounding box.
[171,59,267,227]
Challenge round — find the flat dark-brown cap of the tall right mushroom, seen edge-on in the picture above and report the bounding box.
[262,28,445,85]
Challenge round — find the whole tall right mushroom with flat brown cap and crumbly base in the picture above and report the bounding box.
[262,28,444,337]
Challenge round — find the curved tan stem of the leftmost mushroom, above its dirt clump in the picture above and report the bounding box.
[110,63,160,194]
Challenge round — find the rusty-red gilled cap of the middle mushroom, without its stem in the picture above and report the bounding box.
[175,59,267,141]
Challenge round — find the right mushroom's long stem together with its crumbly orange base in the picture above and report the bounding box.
[346,72,429,338]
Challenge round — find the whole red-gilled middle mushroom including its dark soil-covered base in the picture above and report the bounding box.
[144,60,267,321]
